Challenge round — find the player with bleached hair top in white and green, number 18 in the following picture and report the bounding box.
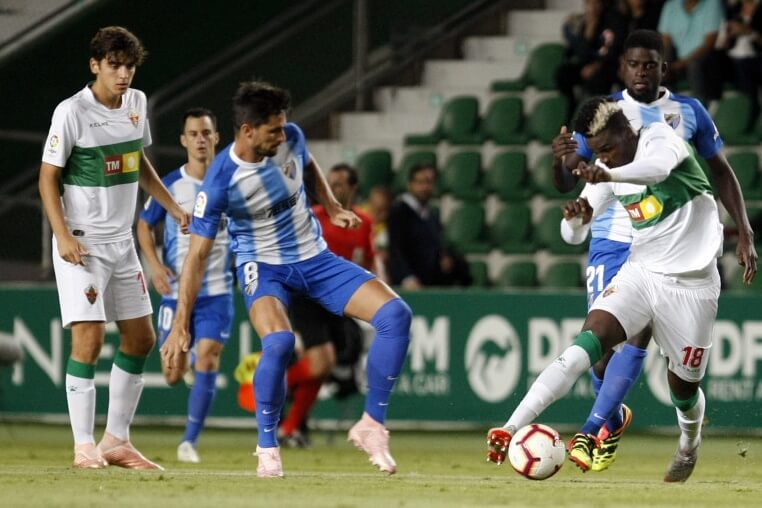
[492,97,756,482]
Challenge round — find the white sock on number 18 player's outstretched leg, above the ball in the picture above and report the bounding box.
[504,345,590,432]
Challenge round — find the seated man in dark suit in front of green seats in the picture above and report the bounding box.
[388,164,471,290]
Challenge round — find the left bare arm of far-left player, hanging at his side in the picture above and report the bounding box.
[38,162,88,265]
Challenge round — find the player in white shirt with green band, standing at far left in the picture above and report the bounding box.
[39,27,189,469]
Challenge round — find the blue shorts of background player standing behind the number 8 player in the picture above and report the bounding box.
[156,295,233,347]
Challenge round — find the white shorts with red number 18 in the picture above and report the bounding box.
[591,261,720,382]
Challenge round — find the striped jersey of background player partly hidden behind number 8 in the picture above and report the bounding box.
[140,166,233,299]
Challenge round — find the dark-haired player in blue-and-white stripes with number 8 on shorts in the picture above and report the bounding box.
[161,82,412,478]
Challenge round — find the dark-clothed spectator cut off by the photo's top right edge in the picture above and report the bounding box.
[720,0,762,118]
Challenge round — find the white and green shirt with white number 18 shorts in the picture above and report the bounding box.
[588,123,722,382]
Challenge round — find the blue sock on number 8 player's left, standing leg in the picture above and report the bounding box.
[254,332,295,448]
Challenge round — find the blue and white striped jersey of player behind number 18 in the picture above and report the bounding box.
[574,87,723,242]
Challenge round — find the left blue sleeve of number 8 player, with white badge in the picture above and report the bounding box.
[189,158,230,239]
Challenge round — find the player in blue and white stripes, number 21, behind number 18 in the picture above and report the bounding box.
[490,30,757,471]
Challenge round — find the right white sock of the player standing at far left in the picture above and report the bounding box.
[106,364,144,441]
